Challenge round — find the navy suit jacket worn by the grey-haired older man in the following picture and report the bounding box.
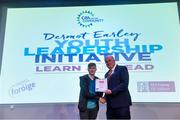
[105,65,132,108]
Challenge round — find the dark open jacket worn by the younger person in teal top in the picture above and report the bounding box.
[78,74,103,111]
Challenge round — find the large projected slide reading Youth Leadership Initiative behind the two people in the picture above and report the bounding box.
[0,2,180,104]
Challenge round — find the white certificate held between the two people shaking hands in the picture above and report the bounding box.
[95,78,107,92]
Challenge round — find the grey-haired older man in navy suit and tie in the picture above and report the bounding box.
[101,55,132,119]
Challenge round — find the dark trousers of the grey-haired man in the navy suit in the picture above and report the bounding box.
[106,107,131,120]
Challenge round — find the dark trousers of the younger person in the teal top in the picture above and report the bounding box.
[79,107,98,119]
